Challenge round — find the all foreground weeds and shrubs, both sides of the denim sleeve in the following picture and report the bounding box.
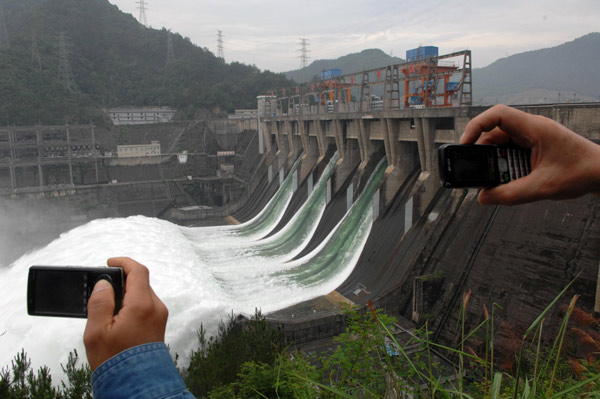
[0,286,600,399]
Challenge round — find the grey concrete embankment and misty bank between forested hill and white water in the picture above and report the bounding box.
[0,120,262,263]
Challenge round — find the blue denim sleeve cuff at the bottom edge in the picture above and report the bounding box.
[92,342,194,399]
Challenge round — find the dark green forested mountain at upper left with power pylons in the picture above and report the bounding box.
[0,0,290,125]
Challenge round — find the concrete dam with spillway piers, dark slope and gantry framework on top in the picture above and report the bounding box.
[169,52,600,356]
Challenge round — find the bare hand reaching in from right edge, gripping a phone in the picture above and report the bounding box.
[460,105,600,205]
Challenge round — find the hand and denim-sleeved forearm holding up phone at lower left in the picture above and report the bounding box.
[84,258,193,399]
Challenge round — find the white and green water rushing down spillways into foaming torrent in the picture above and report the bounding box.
[0,155,385,377]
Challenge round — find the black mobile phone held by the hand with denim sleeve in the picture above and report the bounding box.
[27,266,125,318]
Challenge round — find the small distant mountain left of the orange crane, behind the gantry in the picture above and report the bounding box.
[285,49,404,83]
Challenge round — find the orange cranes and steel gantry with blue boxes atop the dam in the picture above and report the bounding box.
[261,46,472,116]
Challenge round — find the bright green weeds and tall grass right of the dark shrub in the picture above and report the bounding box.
[209,285,600,399]
